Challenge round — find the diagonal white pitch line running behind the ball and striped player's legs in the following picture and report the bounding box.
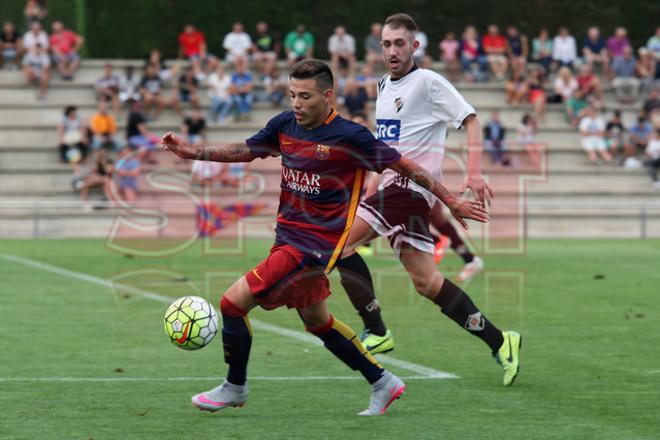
[2,255,459,379]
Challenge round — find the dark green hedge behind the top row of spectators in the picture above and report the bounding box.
[0,0,660,58]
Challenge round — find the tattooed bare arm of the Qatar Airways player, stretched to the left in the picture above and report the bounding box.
[160,132,259,162]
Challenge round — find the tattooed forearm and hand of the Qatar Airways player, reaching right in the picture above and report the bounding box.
[389,157,489,229]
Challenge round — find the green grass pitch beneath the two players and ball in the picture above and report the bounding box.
[0,240,660,440]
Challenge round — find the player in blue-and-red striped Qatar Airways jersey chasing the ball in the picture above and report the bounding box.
[162,60,488,415]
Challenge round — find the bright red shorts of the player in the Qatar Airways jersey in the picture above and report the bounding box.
[245,245,330,310]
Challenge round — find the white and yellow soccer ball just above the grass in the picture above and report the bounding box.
[165,296,218,350]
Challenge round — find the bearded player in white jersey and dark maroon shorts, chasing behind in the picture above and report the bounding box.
[337,14,521,386]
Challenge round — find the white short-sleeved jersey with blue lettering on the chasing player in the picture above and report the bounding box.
[376,68,475,207]
